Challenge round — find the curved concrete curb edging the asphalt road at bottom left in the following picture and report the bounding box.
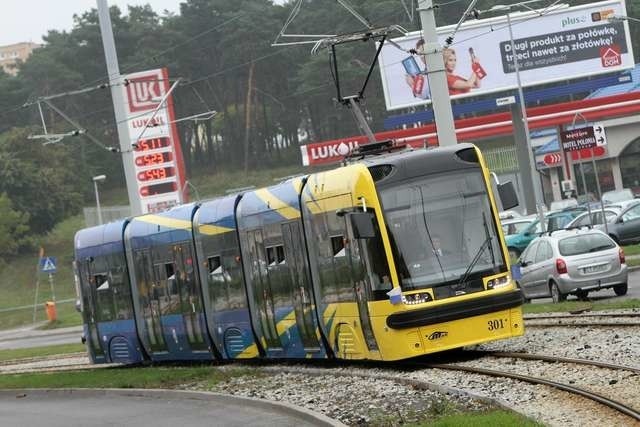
[0,388,347,427]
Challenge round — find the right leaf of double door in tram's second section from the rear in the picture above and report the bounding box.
[173,244,208,350]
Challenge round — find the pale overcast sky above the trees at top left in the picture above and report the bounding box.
[0,0,280,46]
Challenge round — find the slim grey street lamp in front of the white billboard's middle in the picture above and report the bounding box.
[488,0,546,232]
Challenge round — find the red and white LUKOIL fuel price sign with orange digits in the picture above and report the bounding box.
[123,68,185,213]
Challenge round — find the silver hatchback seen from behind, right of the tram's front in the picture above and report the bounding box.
[514,229,628,302]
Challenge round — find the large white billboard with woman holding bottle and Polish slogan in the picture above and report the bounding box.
[379,0,634,110]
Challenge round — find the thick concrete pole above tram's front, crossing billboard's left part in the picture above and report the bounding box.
[418,0,458,147]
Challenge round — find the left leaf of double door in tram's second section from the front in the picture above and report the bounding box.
[247,230,282,349]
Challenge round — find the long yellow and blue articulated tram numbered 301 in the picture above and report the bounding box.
[75,144,524,363]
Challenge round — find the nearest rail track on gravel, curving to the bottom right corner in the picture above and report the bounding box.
[416,351,640,425]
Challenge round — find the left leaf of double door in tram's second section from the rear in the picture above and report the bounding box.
[134,250,167,353]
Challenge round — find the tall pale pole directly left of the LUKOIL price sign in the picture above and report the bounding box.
[97,0,142,215]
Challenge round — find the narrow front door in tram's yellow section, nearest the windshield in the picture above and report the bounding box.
[345,215,378,350]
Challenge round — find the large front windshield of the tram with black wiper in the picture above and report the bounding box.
[380,169,507,291]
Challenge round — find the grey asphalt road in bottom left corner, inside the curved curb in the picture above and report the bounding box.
[0,389,344,427]
